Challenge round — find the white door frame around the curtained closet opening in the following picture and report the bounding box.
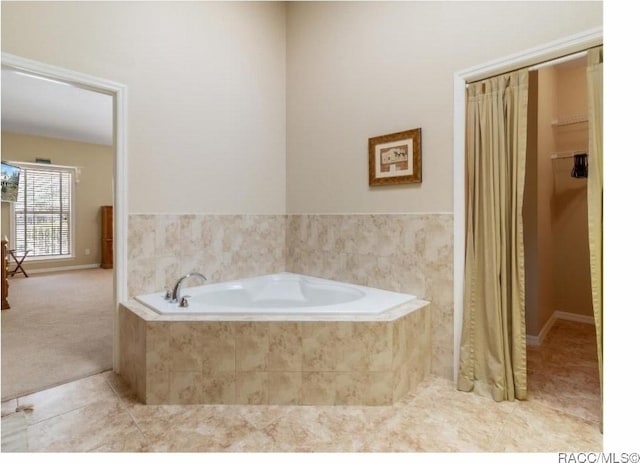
[453,27,603,383]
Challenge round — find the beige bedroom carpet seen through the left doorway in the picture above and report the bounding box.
[2,269,113,400]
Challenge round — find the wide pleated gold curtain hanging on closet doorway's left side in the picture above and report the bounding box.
[457,70,529,401]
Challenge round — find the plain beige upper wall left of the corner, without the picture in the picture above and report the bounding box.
[2,2,286,213]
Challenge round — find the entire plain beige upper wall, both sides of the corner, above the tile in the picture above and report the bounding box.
[2,2,602,218]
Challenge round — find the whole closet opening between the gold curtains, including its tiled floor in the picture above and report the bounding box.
[523,54,601,422]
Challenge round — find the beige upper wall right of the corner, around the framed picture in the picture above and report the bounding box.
[287,2,602,213]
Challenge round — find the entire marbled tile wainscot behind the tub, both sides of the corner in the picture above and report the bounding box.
[128,214,453,379]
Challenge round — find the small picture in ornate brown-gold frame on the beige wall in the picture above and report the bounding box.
[369,129,422,186]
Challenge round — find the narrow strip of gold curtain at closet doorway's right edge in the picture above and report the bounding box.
[587,47,602,402]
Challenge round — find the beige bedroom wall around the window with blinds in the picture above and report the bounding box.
[2,132,113,270]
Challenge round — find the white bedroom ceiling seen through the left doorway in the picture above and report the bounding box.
[1,68,113,145]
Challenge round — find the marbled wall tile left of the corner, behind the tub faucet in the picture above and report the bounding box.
[127,214,286,297]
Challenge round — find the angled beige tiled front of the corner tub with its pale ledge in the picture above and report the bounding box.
[119,300,430,405]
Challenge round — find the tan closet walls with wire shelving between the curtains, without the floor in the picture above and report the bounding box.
[523,56,593,345]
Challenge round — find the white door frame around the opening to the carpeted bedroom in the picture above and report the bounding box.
[2,52,128,373]
